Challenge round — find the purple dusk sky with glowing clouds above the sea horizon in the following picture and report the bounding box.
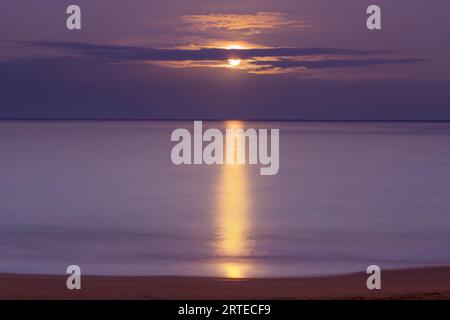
[0,0,450,120]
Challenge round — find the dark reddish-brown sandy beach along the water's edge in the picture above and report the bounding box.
[0,267,450,300]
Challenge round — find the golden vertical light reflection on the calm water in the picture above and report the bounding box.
[217,121,251,278]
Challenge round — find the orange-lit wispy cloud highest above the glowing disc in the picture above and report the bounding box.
[181,12,307,31]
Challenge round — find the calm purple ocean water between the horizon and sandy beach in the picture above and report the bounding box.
[0,122,450,277]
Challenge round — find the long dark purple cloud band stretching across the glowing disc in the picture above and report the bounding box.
[15,42,423,73]
